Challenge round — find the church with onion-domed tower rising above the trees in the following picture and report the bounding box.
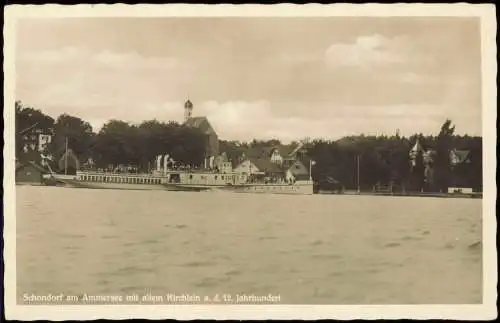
[184,100,219,168]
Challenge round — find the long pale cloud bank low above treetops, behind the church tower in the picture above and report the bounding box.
[147,100,472,142]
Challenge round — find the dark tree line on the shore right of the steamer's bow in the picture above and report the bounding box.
[309,120,482,191]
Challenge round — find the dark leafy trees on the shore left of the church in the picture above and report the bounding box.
[16,102,205,171]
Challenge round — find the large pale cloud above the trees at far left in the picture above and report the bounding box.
[16,47,192,123]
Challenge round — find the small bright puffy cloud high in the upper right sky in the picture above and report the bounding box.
[325,34,407,67]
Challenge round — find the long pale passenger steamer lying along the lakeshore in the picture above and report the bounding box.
[44,170,313,194]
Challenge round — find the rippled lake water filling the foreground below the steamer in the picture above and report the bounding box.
[16,186,482,304]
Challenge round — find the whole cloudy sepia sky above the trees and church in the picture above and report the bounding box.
[16,17,481,141]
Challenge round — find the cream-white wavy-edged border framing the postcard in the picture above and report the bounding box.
[3,3,498,320]
